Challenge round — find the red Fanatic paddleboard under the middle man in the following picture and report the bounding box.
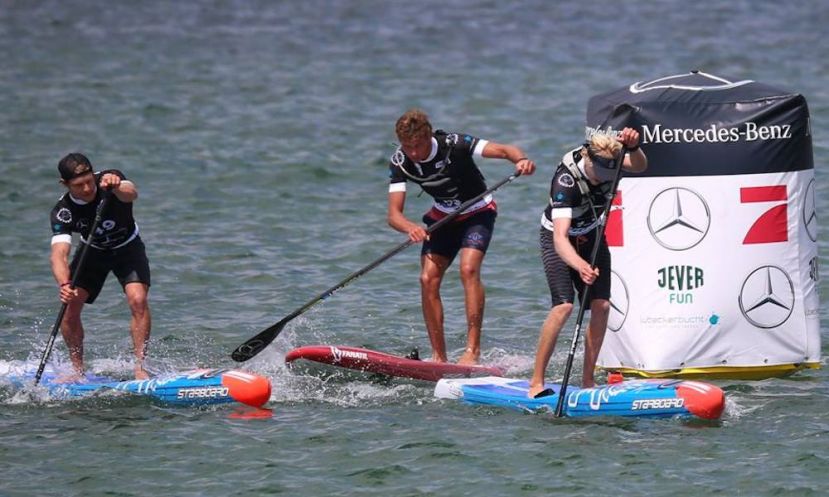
[285,345,504,381]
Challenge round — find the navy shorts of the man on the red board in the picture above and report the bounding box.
[420,209,498,262]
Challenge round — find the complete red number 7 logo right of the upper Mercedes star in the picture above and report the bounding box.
[740,185,789,245]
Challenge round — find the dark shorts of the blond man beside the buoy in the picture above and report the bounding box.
[539,227,610,307]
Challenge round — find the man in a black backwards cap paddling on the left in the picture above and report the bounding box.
[50,153,151,380]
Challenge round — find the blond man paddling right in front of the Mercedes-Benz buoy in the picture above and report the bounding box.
[528,128,648,397]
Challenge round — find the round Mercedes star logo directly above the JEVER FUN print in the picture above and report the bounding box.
[648,187,711,250]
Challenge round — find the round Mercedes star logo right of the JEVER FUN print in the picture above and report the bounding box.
[739,266,794,329]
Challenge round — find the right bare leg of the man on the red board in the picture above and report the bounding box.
[458,248,486,365]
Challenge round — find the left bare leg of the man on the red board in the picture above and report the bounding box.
[420,254,449,362]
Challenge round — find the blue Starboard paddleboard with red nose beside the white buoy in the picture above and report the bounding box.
[435,377,725,419]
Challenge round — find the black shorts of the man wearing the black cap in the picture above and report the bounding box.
[69,238,150,304]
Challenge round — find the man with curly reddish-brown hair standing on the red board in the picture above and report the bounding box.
[388,109,535,365]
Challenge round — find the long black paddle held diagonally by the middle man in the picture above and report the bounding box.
[230,172,521,362]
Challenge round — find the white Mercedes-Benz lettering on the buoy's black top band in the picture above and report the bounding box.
[642,121,792,144]
